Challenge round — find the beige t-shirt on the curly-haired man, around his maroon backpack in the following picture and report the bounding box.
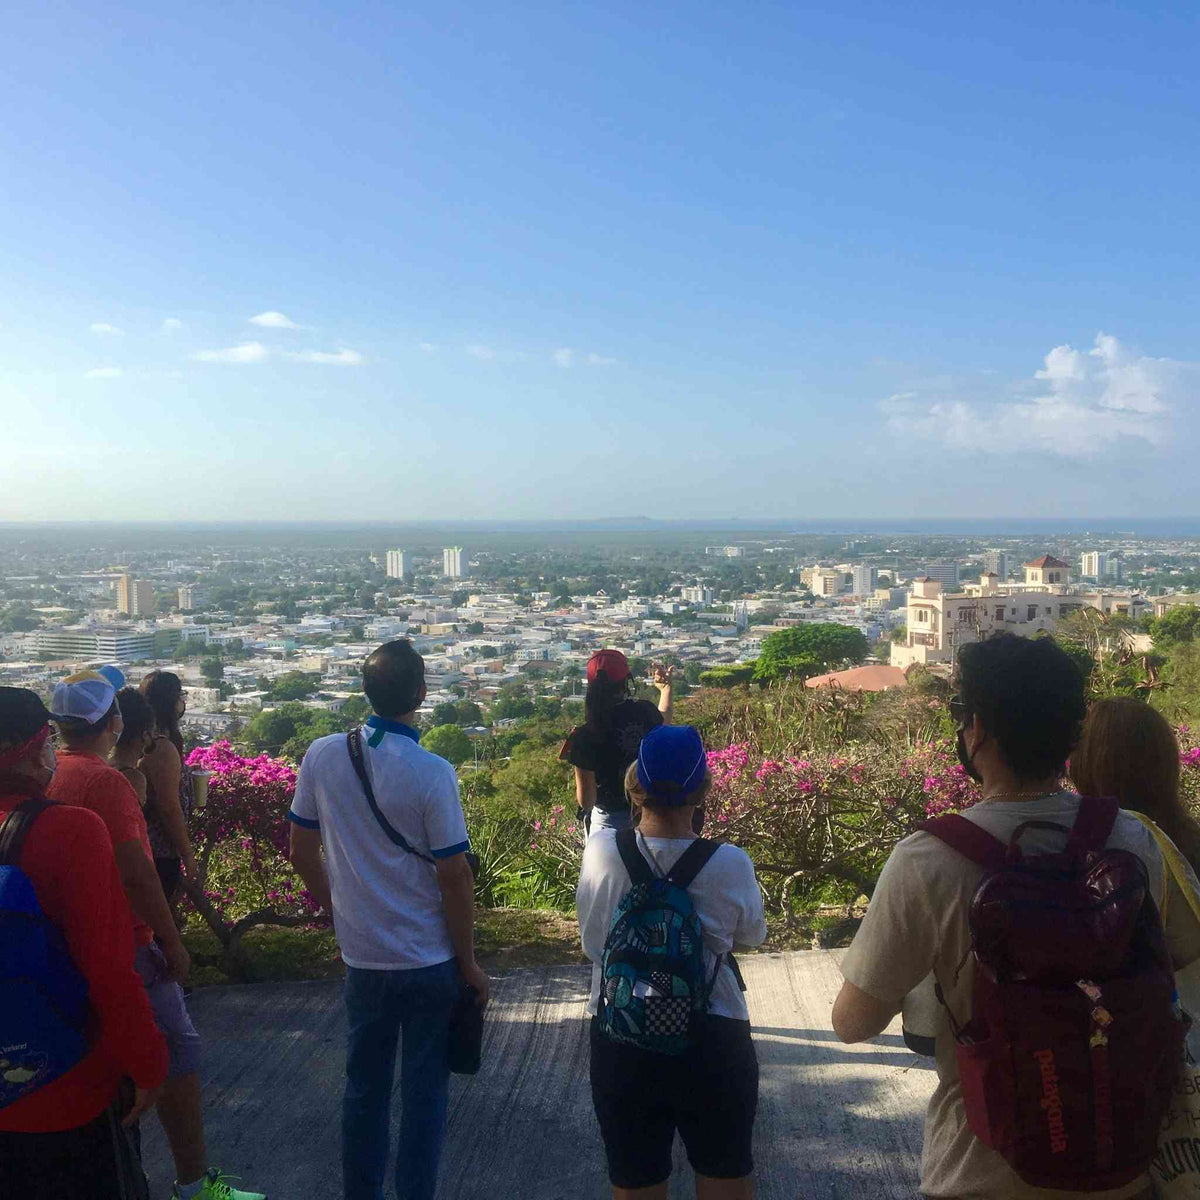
[841,792,1200,1200]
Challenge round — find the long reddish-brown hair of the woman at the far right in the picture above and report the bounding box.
[1070,696,1200,869]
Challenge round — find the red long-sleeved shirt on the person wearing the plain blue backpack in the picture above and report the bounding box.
[0,775,167,1133]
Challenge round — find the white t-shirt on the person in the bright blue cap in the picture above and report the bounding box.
[575,829,767,1021]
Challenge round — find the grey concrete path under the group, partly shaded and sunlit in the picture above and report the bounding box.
[144,950,935,1200]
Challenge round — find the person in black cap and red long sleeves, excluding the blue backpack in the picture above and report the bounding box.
[0,688,167,1200]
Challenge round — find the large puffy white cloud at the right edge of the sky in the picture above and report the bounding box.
[880,334,1200,460]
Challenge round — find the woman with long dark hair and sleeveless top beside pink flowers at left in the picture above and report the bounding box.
[138,671,196,900]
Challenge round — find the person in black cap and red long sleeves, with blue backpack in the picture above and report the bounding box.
[0,688,167,1200]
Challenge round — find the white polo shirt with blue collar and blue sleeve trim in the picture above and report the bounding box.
[288,718,470,971]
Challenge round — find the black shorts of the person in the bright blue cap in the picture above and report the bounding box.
[592,1016,758,1188]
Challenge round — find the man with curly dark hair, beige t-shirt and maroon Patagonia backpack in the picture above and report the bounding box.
[833,634,1200,1200]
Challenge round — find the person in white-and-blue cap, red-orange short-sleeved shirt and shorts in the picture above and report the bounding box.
[48,671,265,1200]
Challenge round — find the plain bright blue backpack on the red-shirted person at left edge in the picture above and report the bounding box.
[0,799,89,1109]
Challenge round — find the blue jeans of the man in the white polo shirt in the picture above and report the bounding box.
[342,959,458,1200]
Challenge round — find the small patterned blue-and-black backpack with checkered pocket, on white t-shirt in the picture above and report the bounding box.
[596,829,724,1055]
